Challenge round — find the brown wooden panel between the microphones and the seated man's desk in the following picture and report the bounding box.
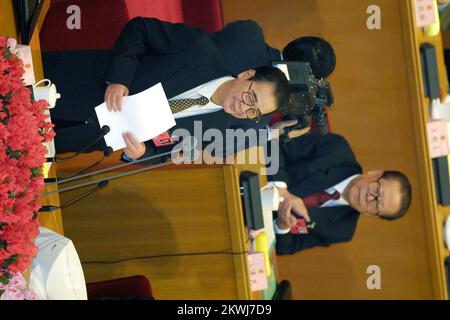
[58,151,274,299]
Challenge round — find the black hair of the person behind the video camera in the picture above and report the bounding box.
[283,37,336,78]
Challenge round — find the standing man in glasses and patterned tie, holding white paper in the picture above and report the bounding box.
[44,17,289,159]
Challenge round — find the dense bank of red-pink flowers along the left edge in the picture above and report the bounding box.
[0,36,55,298]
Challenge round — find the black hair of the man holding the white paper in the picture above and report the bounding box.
[251,66,290,109]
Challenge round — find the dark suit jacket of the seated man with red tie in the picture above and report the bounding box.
[269,132,362,254]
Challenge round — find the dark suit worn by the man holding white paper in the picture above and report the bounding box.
[44,17,270,161]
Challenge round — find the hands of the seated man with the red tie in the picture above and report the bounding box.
[277,188,311,229]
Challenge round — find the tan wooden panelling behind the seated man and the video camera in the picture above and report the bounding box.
[222,0,434,299]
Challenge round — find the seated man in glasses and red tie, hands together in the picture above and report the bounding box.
[269,132,411,254]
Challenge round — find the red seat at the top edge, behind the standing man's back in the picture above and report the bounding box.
[40,0,223,52]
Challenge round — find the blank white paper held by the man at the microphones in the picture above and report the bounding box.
[95,83,176,151]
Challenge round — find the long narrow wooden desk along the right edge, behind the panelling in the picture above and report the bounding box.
[401,1,450,300]
